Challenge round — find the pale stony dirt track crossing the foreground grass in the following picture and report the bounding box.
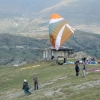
[2,77,100,100]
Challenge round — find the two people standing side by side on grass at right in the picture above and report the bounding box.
[75,58,86,77]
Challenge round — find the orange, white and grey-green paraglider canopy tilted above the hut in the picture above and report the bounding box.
[49,14,75,50]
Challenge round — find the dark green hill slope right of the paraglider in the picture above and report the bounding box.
[65,30,100,58]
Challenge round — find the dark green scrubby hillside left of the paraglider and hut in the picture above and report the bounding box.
[0,34,47,65]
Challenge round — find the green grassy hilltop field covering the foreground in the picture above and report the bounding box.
[0,62,100,100]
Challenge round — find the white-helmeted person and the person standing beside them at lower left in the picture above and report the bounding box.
[22,74,38,95]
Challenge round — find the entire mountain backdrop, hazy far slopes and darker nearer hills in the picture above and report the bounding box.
[0,0,100,64]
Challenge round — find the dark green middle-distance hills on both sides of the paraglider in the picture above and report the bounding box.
[0,30,100,64]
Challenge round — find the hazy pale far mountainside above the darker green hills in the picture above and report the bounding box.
[0,0,100,36]
